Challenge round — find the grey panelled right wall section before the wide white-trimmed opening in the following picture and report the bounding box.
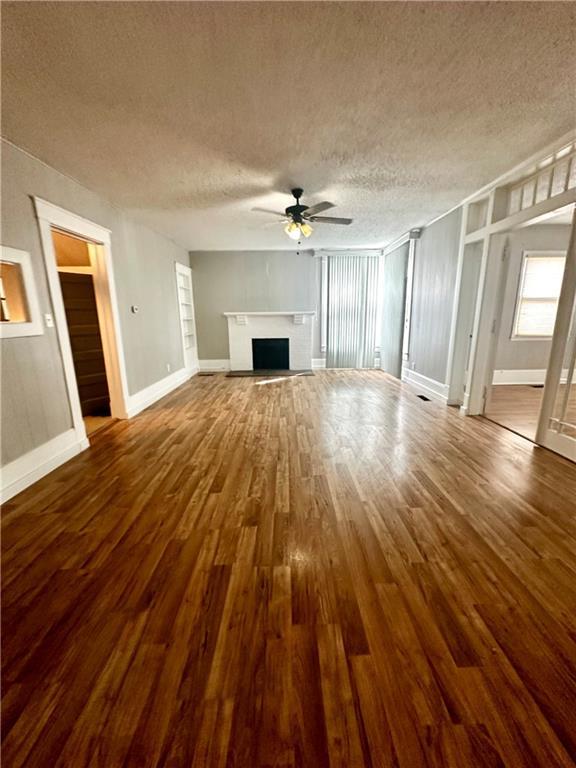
[408,208,462,383]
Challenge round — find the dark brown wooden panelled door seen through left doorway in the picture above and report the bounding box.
[59,272,110,416]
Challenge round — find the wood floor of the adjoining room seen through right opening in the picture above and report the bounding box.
[485,384,576,440]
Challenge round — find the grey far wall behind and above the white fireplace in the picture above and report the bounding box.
[190,251,321,360]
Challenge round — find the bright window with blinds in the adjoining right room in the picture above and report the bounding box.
[512,251,566,338]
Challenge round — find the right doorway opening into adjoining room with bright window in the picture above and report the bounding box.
[483,206,576,443]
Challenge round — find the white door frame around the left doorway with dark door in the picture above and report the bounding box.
[34,197,129,439]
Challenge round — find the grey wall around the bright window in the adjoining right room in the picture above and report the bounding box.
[495,224,570,371]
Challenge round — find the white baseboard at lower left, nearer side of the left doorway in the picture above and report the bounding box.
[0,429,90,503]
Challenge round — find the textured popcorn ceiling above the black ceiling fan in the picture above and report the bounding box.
[2,2,576,249]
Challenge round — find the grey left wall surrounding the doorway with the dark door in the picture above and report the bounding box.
[0,142,189,465]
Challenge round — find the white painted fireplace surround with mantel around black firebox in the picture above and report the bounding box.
[223,309,316,371]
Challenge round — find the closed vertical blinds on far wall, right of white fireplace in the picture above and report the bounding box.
[326,255,380,368]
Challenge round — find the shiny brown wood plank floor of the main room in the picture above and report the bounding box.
[2,371,576,768]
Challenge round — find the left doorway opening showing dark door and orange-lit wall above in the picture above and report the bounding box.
[52,228,113,436]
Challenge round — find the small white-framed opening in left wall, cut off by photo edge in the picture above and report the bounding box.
[0,245,44,339]
